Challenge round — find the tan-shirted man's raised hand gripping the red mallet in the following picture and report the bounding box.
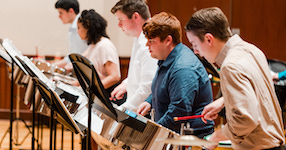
[202,97,224,123]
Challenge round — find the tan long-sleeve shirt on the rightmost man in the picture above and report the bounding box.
[216,35,285,150]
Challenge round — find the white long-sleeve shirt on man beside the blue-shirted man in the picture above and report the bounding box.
[122,32,157,111]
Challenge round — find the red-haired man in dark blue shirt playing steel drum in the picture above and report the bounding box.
[137,12,214,138]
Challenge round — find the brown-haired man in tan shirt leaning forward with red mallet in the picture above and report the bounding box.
[185,7,285,150]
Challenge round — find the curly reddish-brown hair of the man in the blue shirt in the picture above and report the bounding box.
[142,12,182,45]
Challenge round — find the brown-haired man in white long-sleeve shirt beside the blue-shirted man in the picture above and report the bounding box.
[111,0,157,111]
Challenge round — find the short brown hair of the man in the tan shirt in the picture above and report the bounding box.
[185,7,232,41]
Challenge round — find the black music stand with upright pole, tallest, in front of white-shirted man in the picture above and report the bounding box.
[69,54,117,150]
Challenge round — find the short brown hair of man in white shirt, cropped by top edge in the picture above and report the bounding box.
[111,0,151,20]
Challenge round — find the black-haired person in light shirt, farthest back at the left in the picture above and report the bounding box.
[54,0,88,68]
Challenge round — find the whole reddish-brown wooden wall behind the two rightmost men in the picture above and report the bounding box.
[148,0,286,61]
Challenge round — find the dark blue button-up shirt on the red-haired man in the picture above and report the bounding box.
[145,43,214,133]
